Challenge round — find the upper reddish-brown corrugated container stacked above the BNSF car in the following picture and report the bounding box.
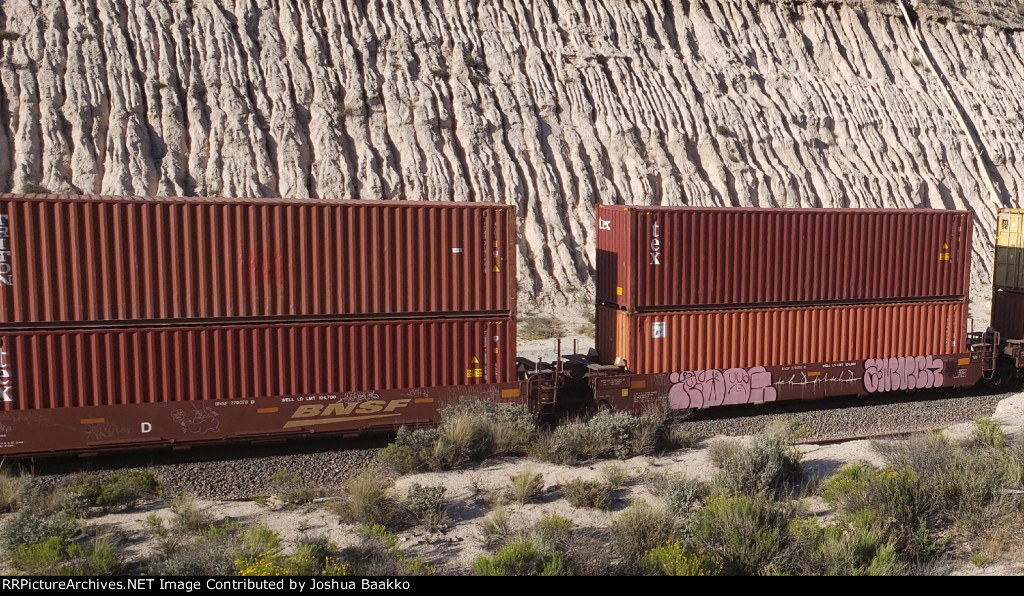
[0,195,516,329]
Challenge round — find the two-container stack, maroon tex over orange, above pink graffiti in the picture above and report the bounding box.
[596,206,972,374]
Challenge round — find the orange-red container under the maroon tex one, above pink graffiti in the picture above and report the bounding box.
[596,302,967,374]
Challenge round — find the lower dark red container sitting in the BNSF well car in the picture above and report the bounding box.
[0,316,516,411]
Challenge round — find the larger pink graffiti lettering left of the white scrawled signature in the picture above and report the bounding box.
[669,367,777,410]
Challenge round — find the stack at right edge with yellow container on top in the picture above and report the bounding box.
[991,209,1024,339]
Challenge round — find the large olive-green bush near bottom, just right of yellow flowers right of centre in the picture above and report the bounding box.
[689,493,795,576]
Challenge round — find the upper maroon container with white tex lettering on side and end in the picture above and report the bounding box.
[596,206,973,311]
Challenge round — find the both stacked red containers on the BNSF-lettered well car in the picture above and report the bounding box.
[0,195,516,442]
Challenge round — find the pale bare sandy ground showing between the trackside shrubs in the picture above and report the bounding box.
[70,393,1024,576]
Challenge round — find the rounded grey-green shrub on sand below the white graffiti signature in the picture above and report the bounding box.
[715,434,802,495]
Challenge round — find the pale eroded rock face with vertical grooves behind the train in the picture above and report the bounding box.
[0,0,1024,317]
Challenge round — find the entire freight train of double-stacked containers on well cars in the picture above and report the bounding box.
[0,195,1024,459]
